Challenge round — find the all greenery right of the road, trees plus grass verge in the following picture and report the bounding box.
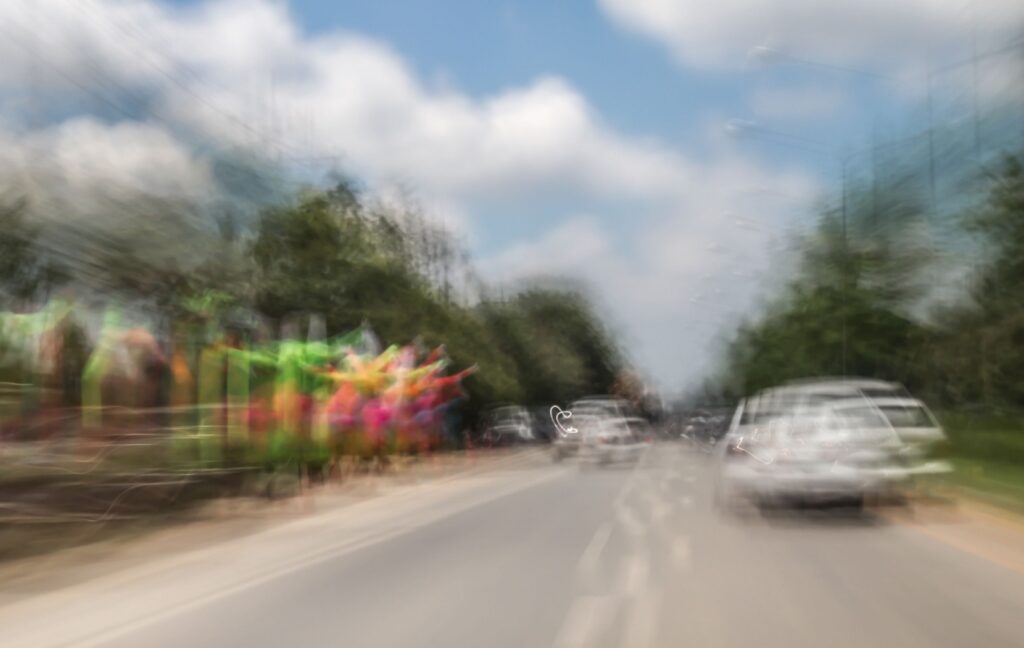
[705,150,1024,504]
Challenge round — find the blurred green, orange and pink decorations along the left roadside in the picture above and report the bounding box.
[0,301,475,465]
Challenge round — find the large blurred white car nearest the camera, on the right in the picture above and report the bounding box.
[716,398,908,506]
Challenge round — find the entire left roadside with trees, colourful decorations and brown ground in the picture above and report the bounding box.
[0,176,626,559]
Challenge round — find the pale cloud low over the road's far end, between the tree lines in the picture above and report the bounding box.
[481,157,815,389]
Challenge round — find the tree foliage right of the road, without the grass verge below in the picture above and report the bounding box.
[722,152,1024,406]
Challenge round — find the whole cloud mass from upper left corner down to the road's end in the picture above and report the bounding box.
[0,0,812,386]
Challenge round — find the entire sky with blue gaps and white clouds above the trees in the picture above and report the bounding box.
[0,0,1024,391]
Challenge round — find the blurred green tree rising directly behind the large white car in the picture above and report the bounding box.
[725,177,931,393]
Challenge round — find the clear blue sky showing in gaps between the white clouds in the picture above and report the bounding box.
[251,0,937,255]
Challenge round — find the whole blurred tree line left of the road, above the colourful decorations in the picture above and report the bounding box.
[0,181,624,434]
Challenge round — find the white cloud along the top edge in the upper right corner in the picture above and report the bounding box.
[598,0,1024,69]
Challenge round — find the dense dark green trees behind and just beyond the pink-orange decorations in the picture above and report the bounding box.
[252,184,623,429]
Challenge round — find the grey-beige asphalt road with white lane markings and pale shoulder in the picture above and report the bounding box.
[0,444,1024,648]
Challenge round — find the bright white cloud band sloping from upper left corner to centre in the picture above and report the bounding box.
[0,0,689,204]
